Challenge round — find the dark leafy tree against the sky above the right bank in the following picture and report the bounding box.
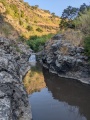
[60,3,90,29]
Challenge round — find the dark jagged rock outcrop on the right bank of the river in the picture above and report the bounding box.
[42,34,90,84]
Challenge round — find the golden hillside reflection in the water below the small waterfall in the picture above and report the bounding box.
[24,62,46,94]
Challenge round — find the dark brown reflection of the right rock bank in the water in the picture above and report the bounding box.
[43,69,90,120]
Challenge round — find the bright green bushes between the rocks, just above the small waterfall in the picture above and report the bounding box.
[27,34,53,52]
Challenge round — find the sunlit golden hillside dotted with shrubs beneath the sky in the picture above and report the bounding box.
[0,0,60,38]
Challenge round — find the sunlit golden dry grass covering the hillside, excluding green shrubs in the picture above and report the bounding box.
[0,0,60,38]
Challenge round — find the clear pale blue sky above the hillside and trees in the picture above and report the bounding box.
[24,0,90,16]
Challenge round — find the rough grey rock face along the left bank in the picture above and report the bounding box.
[0,37,32,120]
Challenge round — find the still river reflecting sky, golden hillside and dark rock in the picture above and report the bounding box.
[24,54,90,120]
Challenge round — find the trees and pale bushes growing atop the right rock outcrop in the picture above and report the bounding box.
[60,3,90,58]
